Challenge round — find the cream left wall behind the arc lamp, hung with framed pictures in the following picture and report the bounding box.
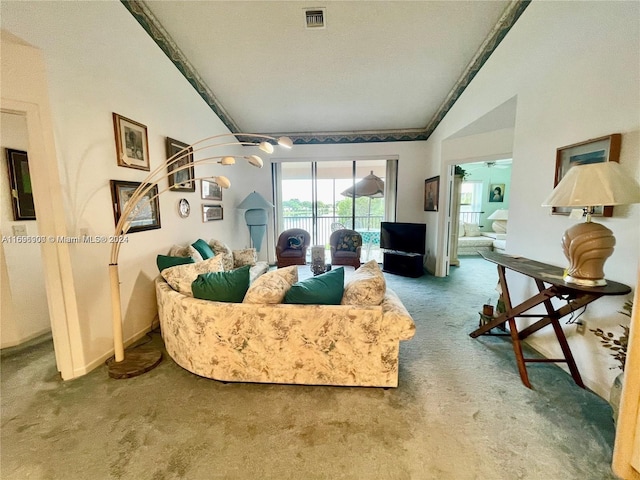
[1,2,268,375]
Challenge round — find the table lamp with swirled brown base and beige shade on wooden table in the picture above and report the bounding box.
[542,162,640,287]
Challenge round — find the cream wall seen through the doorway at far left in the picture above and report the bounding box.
[0,112,51,348]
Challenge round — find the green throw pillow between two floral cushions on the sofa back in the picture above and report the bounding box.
[284,267,344,305]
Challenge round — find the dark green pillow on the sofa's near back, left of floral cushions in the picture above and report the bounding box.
[191,265,251,303]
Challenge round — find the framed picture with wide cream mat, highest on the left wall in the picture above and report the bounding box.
[113,113,149,172]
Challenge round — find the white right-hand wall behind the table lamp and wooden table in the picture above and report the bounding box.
[427,2,640,398]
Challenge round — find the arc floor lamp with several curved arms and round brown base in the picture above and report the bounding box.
[107,133,293,378]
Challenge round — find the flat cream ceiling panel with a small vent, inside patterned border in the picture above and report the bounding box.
[122,0,529,143]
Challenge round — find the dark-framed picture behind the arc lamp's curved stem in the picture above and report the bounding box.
[110,180,160,233]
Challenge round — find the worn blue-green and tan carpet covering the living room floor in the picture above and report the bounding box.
[0,257,615,480]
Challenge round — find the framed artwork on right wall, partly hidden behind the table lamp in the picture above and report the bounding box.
[551,133,622,217]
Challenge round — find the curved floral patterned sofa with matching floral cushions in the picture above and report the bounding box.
[156,261,415,387]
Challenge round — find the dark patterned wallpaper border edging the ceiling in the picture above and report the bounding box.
[120,0,532,145]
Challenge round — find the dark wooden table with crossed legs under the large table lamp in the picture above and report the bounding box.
[470,252,631,388]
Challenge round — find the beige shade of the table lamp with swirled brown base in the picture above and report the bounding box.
[542,162,640,207]
